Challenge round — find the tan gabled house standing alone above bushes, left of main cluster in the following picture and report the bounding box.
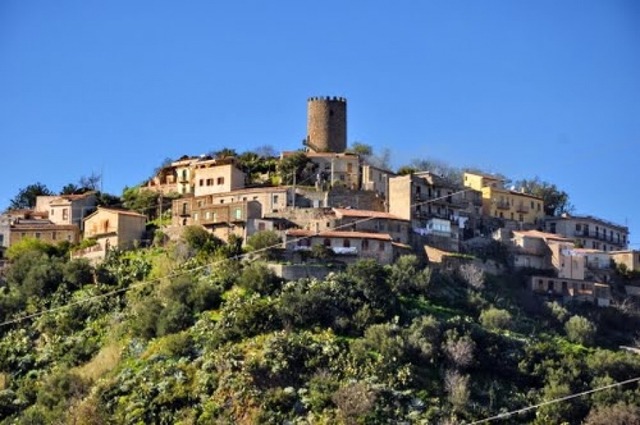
[75,207,147,260]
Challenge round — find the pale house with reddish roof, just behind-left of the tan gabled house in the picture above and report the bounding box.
[35,192,97,229]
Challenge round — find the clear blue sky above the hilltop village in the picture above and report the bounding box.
[0,0,640,242]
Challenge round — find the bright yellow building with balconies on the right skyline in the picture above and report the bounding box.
[464,173,544,224]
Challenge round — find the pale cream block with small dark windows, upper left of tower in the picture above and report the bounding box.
[193,158,245,197]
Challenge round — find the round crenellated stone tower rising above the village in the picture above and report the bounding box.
[306,97,347,153]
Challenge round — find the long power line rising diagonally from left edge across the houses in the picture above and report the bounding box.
[0,189,472,328]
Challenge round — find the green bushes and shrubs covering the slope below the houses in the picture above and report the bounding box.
[0,238,640,425]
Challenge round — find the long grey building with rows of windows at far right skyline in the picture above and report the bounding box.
[544,214,629,251]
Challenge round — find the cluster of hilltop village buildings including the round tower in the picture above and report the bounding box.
[0,97,640,306]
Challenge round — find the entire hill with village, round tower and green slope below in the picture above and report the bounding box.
[0,97,640,425]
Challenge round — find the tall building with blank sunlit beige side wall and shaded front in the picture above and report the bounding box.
[389,171,469,251]
